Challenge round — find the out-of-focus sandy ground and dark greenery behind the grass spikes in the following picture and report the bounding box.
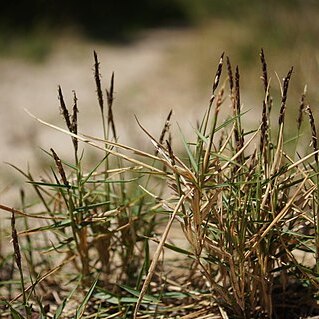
[0,0,319,205]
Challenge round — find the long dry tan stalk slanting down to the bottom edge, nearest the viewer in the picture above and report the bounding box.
[133,194,188,319]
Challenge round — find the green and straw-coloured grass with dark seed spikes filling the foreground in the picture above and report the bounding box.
[1,51,319,318]
